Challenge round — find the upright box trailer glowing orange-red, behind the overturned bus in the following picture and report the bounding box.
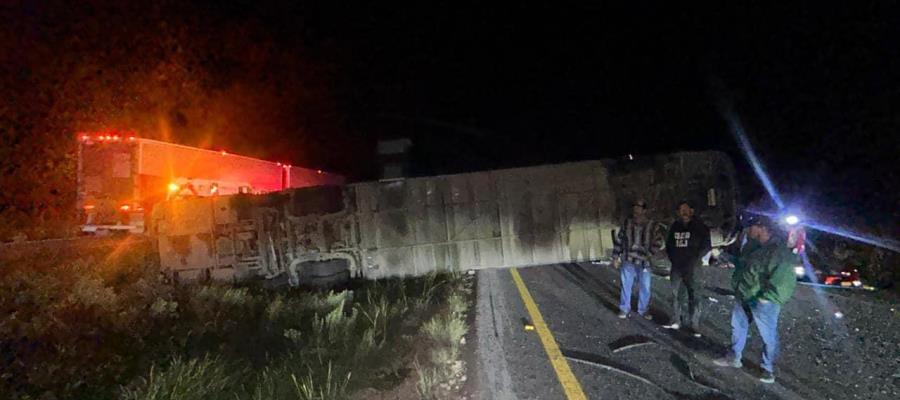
[77,131,344,233]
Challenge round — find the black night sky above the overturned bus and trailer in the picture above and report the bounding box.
[4,0,900,225]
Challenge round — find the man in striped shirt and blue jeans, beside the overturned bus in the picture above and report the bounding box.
[613,200,655,320]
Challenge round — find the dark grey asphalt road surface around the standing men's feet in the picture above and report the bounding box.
[470,263,900,399]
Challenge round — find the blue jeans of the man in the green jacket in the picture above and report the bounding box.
[731,301,781,372]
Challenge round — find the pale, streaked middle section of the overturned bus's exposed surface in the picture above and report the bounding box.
[353,161,615,278]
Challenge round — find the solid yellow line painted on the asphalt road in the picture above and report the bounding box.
[509,268,587,400]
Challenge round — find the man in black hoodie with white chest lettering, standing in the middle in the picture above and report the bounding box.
[664,201,712,337]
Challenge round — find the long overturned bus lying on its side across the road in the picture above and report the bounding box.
[153,152,737,286]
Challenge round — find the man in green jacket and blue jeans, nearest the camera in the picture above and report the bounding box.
[714,217,797,383]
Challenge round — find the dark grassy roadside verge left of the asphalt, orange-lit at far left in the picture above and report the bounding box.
[0,241,474,400]
